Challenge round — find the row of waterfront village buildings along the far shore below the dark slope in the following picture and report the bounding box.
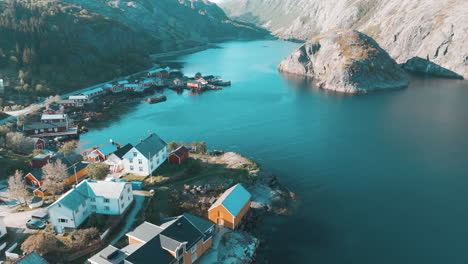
[23,67,231,138]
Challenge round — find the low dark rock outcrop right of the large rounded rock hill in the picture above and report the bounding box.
[401,57,463,80]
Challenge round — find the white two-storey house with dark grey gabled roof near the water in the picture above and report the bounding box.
[123,133,167,176]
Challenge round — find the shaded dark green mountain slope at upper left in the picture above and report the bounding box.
[0,0,268,98]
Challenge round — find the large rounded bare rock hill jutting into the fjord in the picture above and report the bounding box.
[278,30,409,93]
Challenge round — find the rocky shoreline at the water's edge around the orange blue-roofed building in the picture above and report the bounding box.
[192,152,296,264]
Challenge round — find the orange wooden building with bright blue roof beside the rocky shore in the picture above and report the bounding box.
[208,183,252,229]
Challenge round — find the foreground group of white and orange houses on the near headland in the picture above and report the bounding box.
[0,129,251,264]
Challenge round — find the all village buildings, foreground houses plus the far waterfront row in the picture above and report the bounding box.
[0,68,251,264]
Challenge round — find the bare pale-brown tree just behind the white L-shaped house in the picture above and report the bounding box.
[42,160,70,200]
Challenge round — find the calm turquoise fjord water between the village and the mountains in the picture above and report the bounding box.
[82,41,468,264]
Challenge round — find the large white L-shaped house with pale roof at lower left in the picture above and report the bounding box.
[48,180,133,233]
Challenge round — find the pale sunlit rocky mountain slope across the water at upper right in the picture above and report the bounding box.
[221,0,468,78]
